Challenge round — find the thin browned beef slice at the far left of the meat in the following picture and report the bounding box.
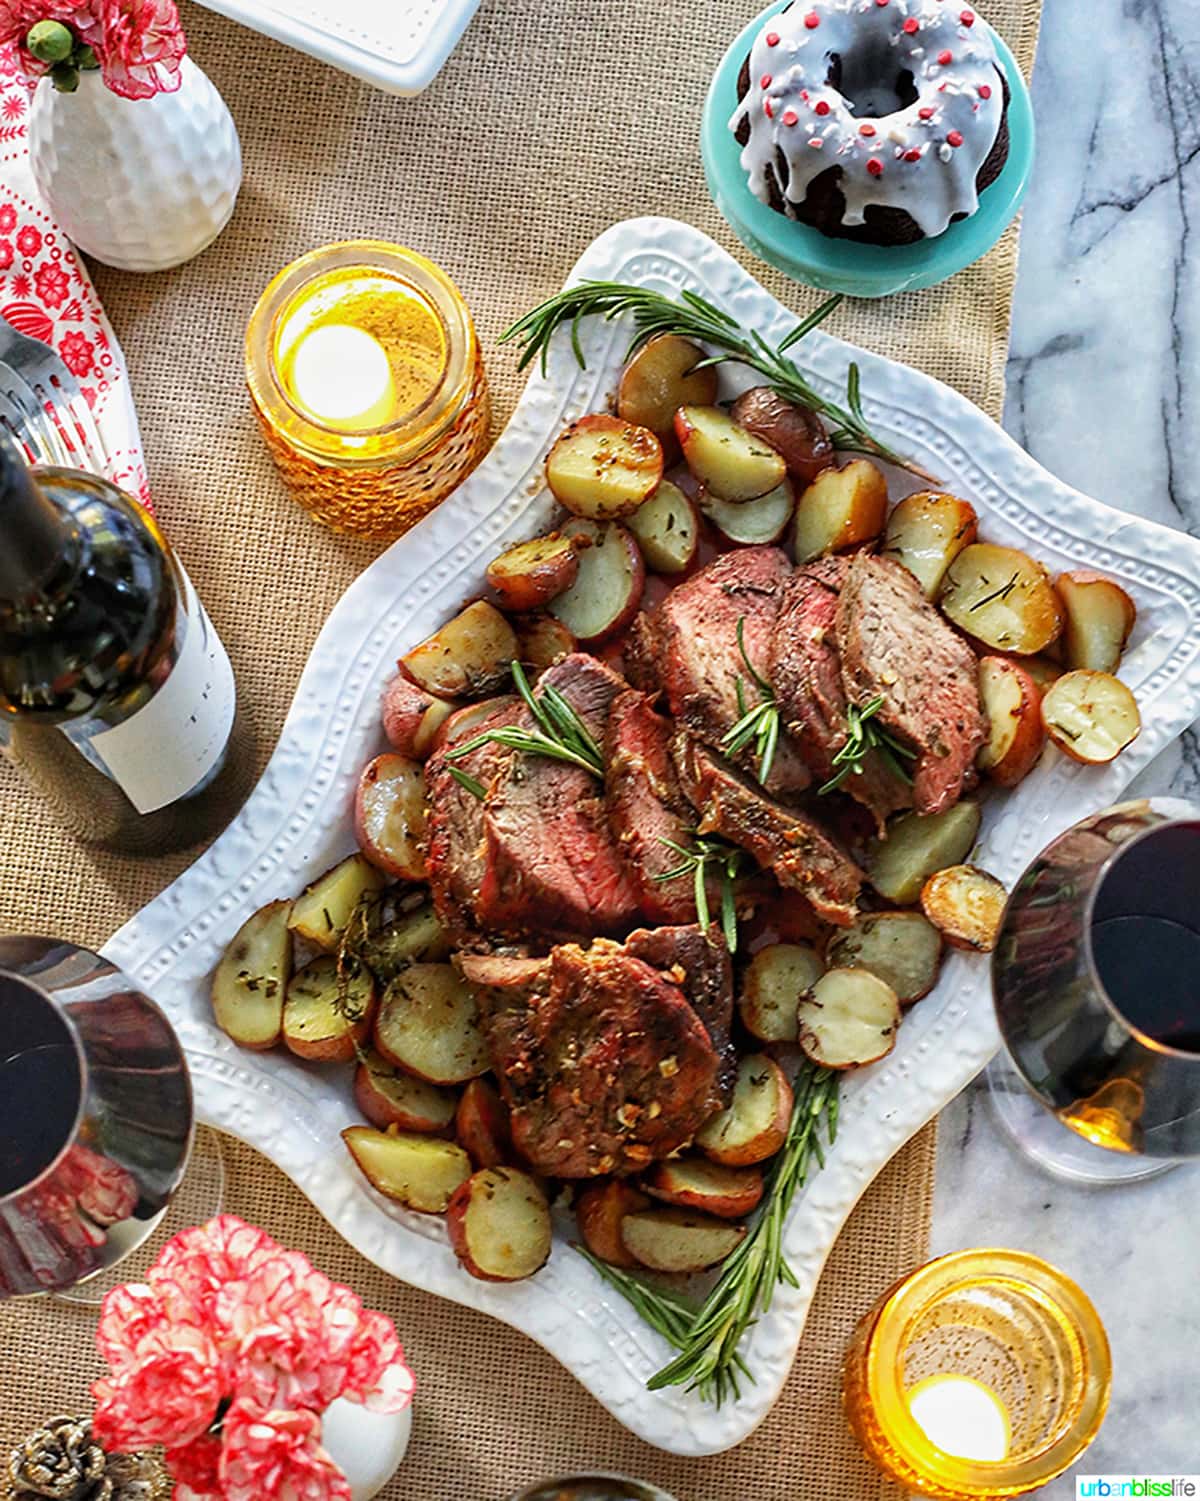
[425,698,515,935]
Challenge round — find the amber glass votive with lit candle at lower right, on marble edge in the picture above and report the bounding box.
[843,1250,1111,1501]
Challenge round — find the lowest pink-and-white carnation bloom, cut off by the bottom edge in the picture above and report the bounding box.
[221,1402,350,1501]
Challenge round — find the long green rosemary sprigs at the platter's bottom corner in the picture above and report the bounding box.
[575,1063,838,1406]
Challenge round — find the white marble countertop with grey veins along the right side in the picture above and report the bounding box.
[933,0,1200,1482]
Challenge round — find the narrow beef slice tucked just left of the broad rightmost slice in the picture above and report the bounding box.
[770,557,912,832]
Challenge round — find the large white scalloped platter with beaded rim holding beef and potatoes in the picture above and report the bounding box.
[105,218,1200,1454]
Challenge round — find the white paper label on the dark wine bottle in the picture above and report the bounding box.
[65,567,237,814]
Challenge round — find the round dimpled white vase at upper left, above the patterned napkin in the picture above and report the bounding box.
[29,57,242,272]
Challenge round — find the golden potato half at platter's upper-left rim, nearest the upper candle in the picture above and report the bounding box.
[545,411,662,521]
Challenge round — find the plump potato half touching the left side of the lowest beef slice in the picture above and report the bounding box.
[374,964,491,1084]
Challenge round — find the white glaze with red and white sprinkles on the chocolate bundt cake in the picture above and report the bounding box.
[730,0,1003,236]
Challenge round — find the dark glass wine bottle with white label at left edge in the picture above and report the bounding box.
[0,443,249,854]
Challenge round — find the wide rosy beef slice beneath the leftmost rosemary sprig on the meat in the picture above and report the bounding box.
[475,651,638,940]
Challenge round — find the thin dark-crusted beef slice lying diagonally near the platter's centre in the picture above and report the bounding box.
[671,734,862,928]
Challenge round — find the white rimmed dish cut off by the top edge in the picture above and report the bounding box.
[200,0,479,95]
